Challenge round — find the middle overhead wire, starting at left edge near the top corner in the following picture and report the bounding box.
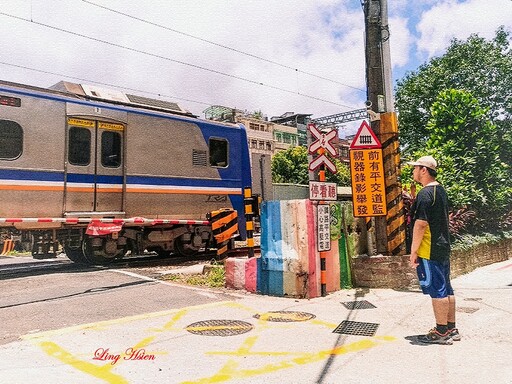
[0,12,354,109]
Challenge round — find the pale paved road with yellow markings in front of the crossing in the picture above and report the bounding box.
[0,254,512,384]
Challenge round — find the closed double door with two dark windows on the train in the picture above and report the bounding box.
[65,118,125,213]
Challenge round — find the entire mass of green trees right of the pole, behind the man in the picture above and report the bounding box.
[396,29,512,231]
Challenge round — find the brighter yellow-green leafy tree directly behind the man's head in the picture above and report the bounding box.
[402,89,512,228]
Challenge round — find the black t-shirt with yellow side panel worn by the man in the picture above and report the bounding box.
[411,184,450,261]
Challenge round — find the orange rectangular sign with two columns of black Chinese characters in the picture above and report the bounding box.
[350,149,387,217]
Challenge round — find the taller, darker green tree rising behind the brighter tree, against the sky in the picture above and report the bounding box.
[395,27,512,160]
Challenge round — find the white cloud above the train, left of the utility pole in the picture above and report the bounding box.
[0,0,365,120]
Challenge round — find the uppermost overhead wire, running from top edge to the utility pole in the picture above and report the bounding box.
[82,0,366,92]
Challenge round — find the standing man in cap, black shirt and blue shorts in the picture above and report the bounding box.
[408,156,460,344]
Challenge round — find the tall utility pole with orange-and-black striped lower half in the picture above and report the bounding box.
[363,0,405,255]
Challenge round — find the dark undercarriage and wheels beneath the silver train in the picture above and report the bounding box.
[0,209,242,265]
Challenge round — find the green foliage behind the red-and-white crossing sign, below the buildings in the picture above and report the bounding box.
[272,146,350,186]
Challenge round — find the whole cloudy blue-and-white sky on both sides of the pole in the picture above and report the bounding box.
[0,0,512,136]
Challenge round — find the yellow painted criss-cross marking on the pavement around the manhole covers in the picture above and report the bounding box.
[22,301,396,384]
